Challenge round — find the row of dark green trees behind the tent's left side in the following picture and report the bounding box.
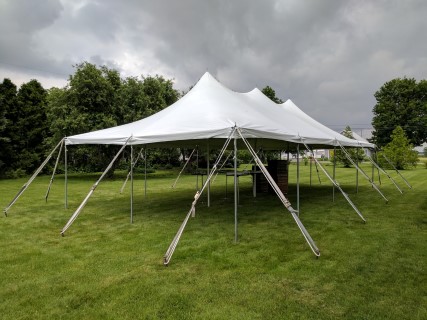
[0,62,182,177]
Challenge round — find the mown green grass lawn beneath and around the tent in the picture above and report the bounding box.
[0,165,427,319]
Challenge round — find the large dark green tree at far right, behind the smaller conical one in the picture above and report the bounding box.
[372,78,427,147]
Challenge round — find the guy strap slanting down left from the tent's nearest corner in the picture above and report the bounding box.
[163,128,236,266]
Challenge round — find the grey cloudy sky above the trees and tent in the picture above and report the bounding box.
[0,0,427,133]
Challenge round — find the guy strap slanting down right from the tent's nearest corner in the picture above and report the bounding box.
[237,128,320,257]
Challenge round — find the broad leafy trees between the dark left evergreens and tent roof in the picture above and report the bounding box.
[48,62,179,173]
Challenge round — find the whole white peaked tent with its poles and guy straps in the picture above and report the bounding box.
[5,73,374,264]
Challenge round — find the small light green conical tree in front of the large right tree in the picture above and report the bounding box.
[378,126,418,170]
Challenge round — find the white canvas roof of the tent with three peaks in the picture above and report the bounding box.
[66,72,374,149]
